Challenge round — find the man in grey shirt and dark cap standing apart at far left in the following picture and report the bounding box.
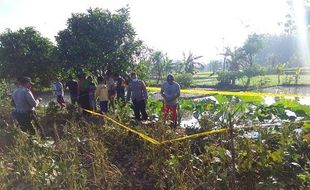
[12,77,45,137]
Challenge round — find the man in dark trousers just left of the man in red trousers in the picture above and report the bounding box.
[126,73,148,121]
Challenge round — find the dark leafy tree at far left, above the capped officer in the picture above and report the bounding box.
[0,27,58,86]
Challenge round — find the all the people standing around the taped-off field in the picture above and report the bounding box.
[12,73,180,135]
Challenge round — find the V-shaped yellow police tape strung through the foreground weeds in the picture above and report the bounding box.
[82,109,310,145]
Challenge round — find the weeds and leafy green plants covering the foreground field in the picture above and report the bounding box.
[0,95,310,189]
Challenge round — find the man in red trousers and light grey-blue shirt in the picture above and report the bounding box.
[160,74,180,127]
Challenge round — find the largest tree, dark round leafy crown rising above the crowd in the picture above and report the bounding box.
[56,8,142,75]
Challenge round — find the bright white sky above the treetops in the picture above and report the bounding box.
[0,0,288,63]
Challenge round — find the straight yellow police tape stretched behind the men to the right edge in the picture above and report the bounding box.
[147,87,310,98]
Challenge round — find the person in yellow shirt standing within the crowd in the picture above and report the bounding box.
[95,77,109,113]
